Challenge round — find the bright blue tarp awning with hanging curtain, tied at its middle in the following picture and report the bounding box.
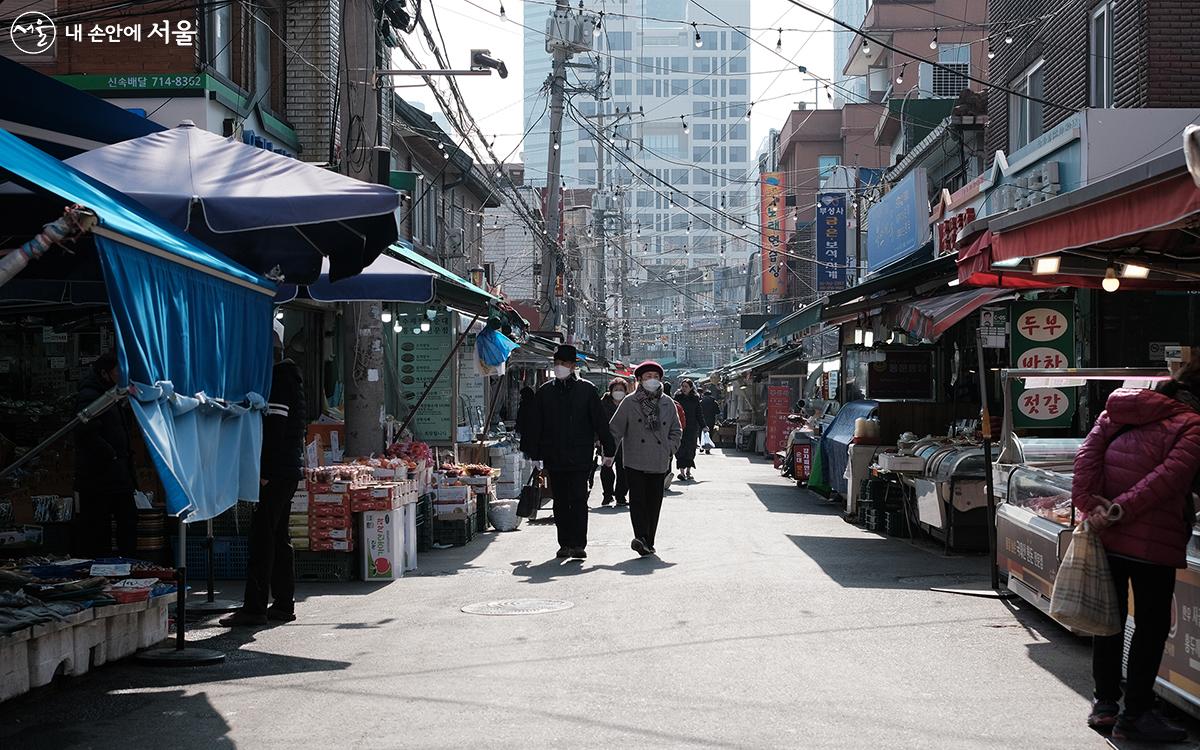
[0,130,275,521]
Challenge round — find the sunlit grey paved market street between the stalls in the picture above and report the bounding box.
[0,446,1195,750]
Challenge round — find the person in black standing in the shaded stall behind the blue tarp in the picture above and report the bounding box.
[74,352,138,557]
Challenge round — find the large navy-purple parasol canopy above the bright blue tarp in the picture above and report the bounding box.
[67,122,400,284]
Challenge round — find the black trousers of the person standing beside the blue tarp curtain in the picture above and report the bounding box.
[241,480,299,614]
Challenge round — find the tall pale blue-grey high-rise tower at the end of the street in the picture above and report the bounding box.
[524,0,757,278]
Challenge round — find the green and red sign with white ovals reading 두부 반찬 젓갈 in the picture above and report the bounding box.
[1009,300,1078,430]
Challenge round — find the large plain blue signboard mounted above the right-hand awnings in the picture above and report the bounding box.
[866,167,929,271]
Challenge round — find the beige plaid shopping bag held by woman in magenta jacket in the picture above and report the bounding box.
[1050,521,1122,636]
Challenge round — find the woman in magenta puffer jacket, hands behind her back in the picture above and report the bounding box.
[1072,360,1200,742]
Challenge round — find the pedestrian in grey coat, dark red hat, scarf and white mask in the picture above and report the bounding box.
[611,361,683,557]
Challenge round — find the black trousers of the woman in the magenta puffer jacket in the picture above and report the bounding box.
[1092,554,1175,716]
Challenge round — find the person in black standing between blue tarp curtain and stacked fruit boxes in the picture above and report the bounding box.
[221,320,307,625]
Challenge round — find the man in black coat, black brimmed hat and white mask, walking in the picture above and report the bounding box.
[521,344,616,559]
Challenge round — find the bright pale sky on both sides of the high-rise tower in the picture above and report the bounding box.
[396,0,836,161]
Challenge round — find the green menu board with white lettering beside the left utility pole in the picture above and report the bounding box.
[396,311,455,443]
